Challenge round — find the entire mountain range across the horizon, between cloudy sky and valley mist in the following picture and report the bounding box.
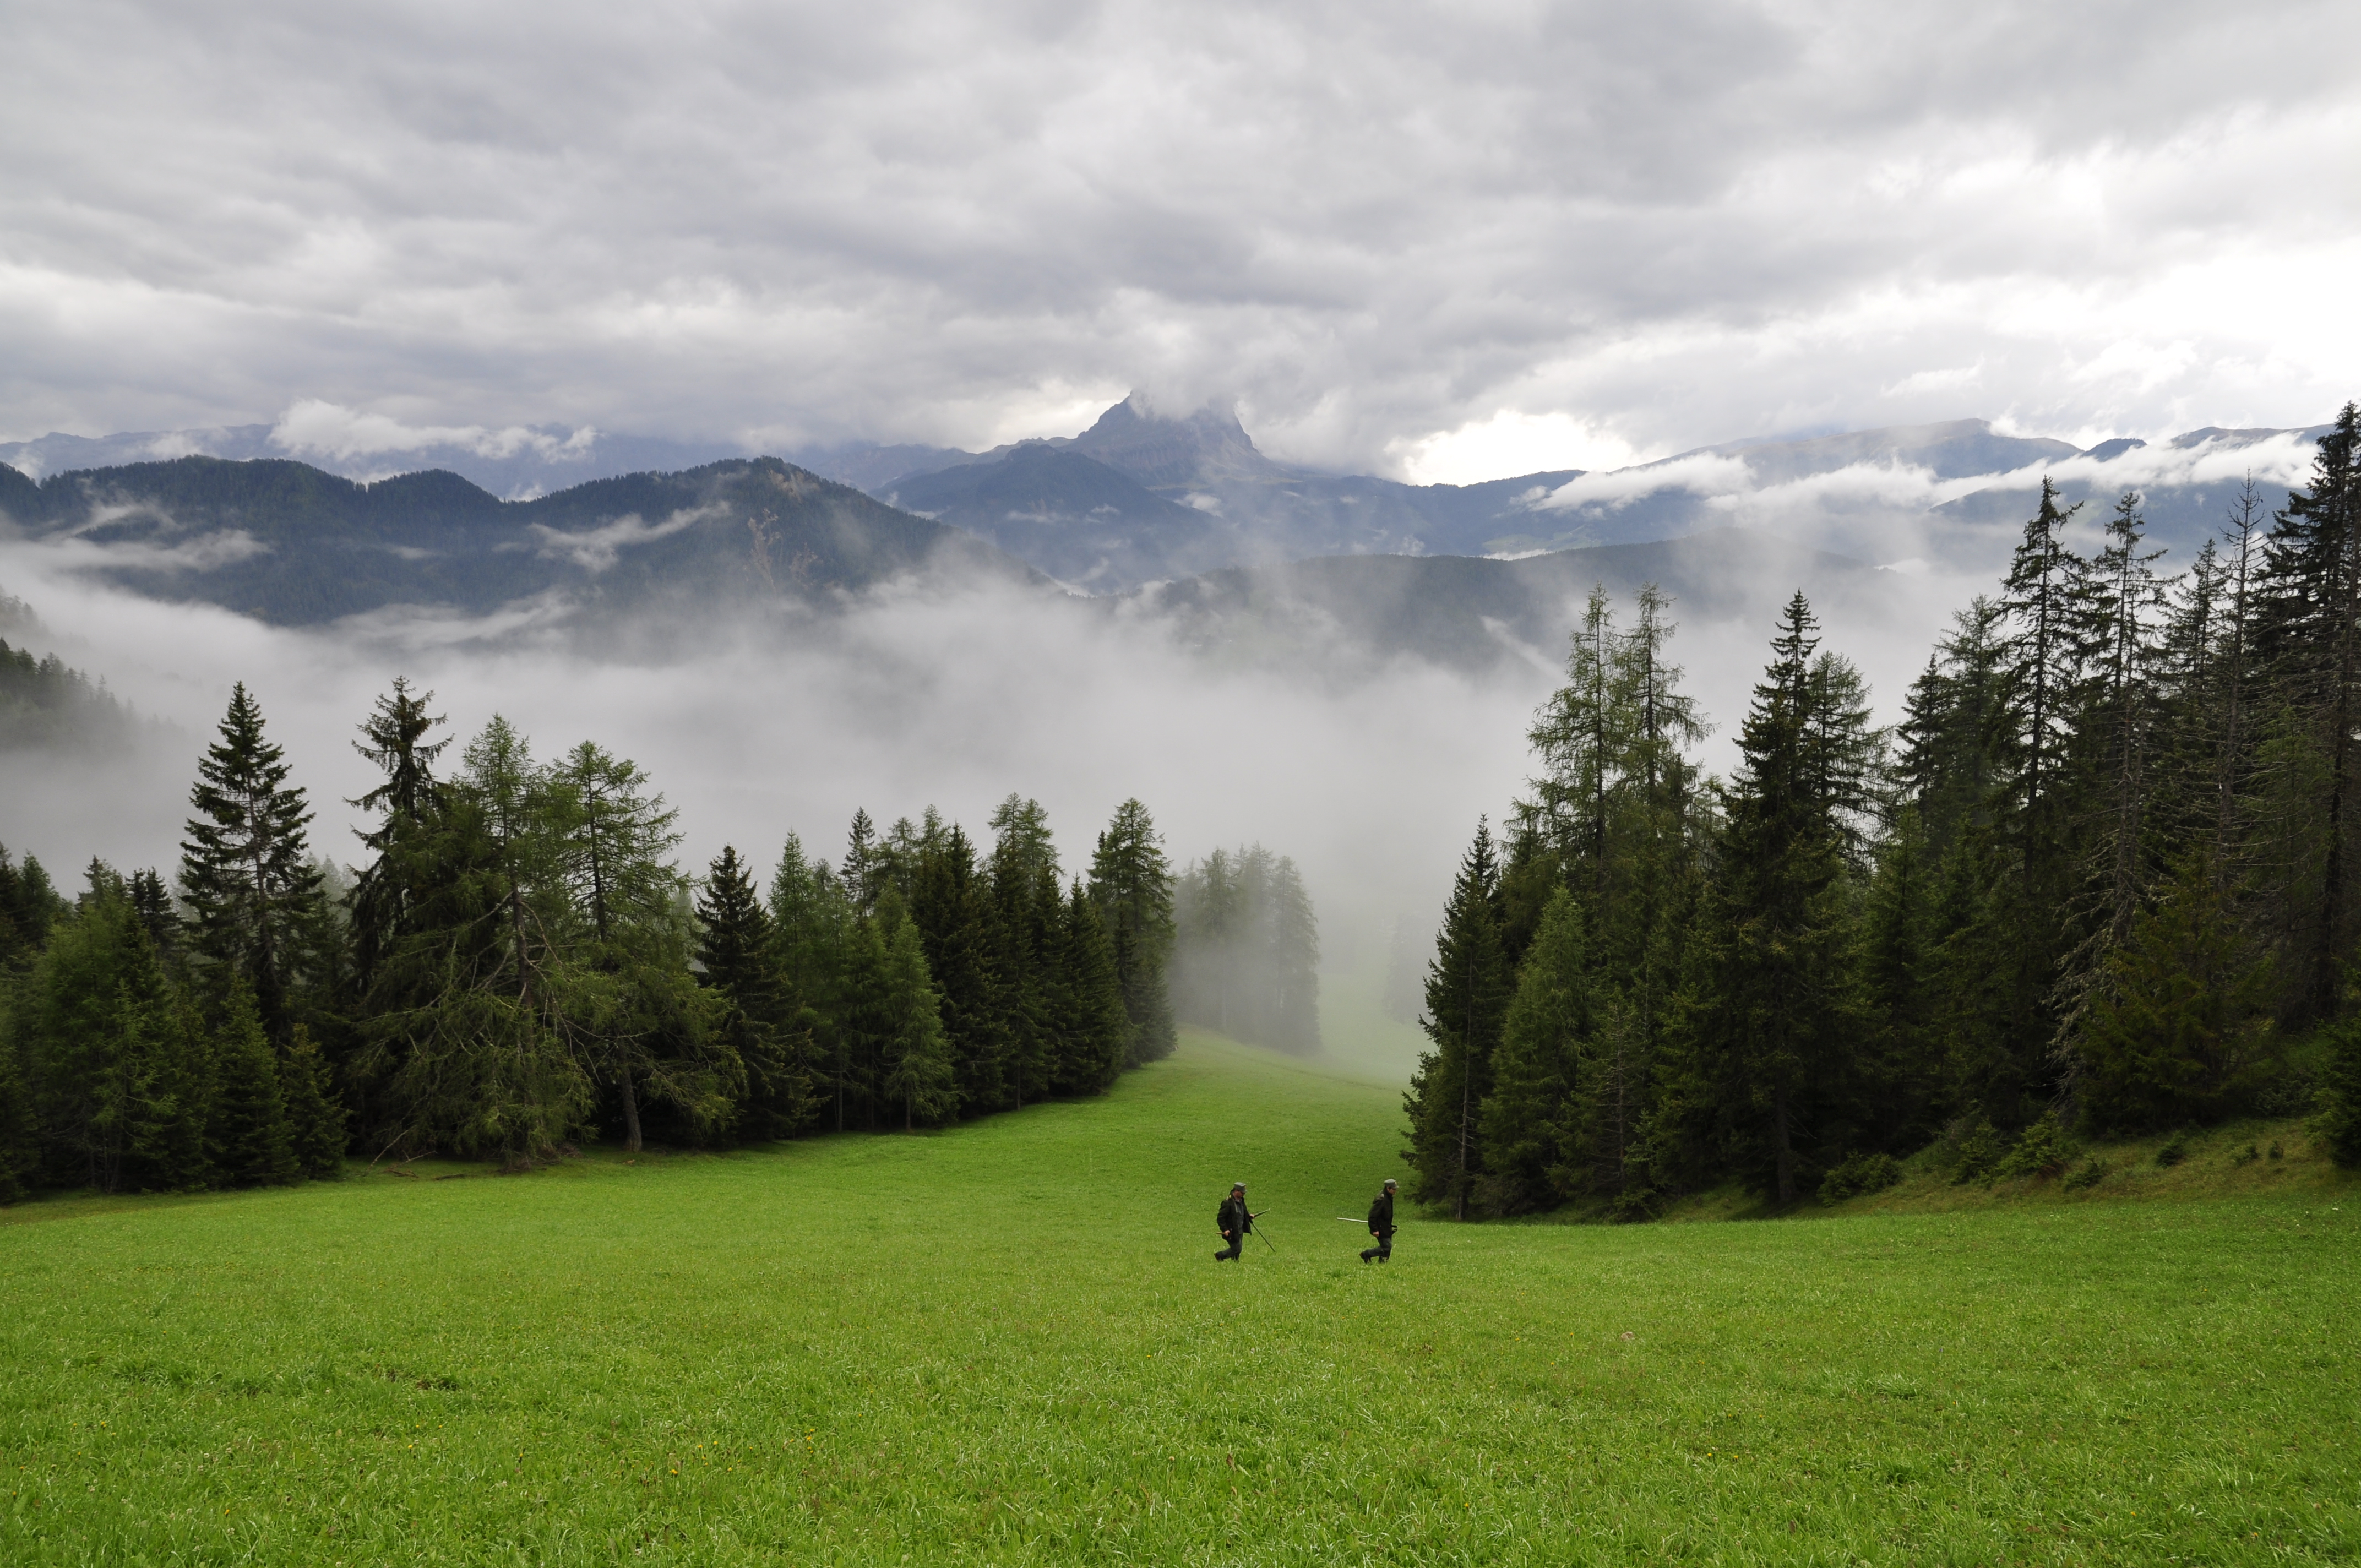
[0,399,2319,668]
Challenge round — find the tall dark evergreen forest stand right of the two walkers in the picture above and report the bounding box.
[1405,404,2361,1218]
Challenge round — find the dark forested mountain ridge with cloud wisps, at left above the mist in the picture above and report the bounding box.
[0,458,1039,626]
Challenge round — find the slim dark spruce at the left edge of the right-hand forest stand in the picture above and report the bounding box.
[1402,822,1511,1218]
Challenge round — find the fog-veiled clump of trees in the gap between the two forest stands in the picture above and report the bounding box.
[1171,843,1320,1055]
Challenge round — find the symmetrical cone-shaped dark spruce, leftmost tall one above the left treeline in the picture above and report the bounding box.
[179,683,319,1039]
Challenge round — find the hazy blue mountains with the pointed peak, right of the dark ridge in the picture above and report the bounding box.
[812,399,2326,593]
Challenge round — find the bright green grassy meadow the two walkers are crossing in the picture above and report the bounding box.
[0,1037,2361,1563]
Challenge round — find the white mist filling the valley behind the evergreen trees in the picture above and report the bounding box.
[0,470,2087,1077]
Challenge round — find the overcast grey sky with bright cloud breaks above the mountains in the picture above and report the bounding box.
[0,0,2361,480]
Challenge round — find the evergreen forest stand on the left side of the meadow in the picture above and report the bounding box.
[0,680,1176,1200]
